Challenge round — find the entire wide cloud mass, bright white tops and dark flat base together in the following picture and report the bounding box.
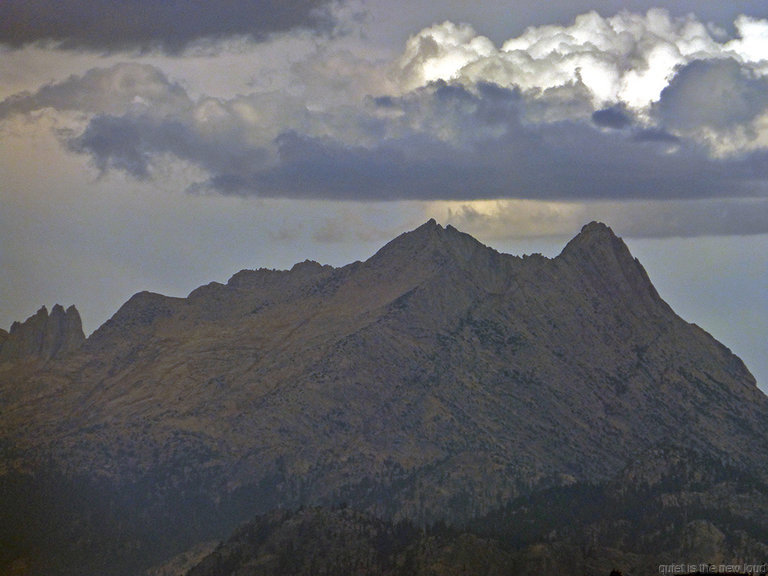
[0,9,768,235]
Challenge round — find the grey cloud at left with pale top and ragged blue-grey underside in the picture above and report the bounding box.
[0,63,306,180]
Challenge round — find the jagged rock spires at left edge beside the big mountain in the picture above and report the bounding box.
[0,304,85,362]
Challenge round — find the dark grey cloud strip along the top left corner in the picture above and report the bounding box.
[0,0,340,52]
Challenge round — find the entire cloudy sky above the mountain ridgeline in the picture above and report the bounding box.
[0,0,768,390]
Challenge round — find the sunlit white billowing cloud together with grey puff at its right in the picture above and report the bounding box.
[390,9,768,157]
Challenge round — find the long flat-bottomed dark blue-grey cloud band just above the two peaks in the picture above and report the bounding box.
[255,108,766,200]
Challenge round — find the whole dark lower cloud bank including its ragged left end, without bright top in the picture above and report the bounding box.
[58,78,766,200]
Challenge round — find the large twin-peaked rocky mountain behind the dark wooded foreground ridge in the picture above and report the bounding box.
[0,220,768,574]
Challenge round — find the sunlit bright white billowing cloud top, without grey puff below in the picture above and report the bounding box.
[400,9,768,116]
